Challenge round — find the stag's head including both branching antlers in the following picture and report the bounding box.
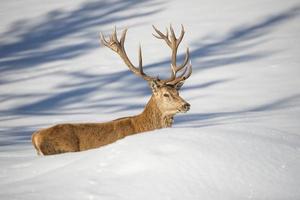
[100,26,192,115]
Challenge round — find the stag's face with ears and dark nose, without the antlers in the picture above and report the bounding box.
[150,79,190,115]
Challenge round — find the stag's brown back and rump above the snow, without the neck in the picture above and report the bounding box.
[32,118,135,155]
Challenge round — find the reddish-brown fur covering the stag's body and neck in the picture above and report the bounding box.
[32,88,190,155]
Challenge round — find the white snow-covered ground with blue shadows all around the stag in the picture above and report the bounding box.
[0,0,300,200]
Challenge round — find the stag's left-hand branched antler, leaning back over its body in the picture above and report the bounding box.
[100,27,155,81]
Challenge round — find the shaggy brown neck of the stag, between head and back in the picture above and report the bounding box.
[134,96,174,132]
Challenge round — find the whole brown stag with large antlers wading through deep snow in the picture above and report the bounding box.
[32,25,192,155]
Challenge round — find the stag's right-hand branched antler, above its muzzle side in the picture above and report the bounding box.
[152,25,192,85]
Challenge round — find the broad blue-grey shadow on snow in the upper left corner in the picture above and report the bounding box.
[0,0,162,74]
